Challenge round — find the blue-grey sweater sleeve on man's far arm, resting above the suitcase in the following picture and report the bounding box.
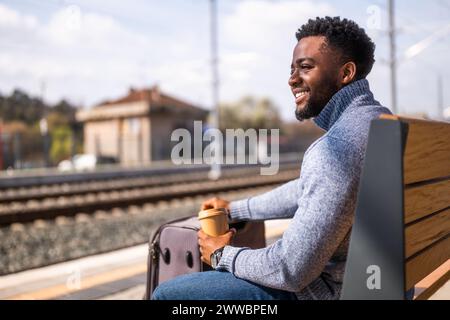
[230,179,299,221]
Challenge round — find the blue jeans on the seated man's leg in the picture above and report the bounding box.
[152,271,297,300]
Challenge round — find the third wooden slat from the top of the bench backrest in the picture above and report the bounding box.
[405,208,450,258]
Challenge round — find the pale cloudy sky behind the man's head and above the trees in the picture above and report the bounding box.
[0,0,450,121]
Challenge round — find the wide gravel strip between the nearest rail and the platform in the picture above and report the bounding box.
[0,185,276,276]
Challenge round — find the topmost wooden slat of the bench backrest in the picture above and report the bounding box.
[401,119,450,184]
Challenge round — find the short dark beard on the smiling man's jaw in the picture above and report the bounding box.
[295,78,339,121]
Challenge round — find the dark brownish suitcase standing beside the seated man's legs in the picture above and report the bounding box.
[144,216,266,299]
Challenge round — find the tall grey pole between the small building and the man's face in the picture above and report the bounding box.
[209,0,222,180]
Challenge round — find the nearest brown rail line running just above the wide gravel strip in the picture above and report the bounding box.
[0,168,299,226]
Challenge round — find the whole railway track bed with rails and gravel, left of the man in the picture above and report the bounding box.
[0,155,301,275]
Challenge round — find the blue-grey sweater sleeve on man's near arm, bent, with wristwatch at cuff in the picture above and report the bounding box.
[218,139,360,292]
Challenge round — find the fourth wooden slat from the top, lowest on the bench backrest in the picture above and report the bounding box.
[405,237,450,290]
